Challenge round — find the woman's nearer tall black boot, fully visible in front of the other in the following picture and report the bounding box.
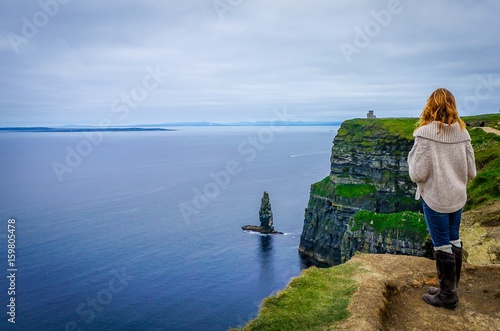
[422,251,458,310]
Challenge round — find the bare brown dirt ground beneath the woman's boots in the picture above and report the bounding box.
[332,254,500,331]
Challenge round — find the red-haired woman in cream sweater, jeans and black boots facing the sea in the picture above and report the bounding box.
[408,88,476,309]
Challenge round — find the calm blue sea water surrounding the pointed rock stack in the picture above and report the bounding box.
[0,127,337,330]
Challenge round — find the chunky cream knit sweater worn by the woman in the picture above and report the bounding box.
[408,122,476,213]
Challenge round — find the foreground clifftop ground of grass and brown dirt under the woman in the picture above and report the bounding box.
[242,254,500,331]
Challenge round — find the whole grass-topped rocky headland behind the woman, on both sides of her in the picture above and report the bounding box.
[299,114,500,266]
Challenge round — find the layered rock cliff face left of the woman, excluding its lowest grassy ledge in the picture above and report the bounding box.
[299,119,424,265]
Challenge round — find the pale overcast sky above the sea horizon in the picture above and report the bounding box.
[0,0,500,126]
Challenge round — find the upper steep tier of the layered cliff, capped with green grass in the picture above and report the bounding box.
[330,119,415,213]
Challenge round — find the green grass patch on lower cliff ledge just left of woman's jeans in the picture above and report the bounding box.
[351,210,427,240]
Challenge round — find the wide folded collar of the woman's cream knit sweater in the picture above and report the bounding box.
[413,121,470,143]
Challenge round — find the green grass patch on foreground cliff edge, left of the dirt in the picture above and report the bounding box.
[236,264,364,331]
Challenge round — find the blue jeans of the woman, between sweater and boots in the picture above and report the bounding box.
[422,199,462,247]
